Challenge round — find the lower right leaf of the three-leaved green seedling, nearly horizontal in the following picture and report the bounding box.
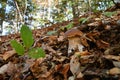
[28,48,45,59]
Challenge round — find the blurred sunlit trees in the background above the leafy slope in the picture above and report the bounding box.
[0,0,114,35]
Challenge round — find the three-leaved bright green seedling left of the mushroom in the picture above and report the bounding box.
[11,25,45,59]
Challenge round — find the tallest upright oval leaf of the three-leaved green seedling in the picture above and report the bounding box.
[20,25,34,49]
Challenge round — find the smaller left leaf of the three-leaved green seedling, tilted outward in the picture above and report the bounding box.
[11,40,25,55]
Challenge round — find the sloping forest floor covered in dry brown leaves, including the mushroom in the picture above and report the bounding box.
[0,6,120,80]
